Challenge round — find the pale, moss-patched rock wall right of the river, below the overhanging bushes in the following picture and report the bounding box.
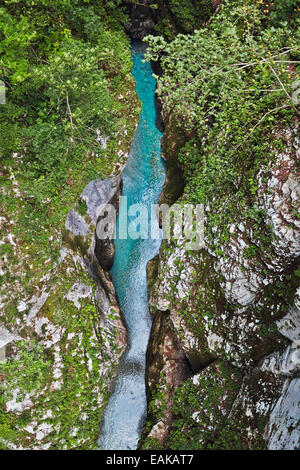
[141,116,300,449]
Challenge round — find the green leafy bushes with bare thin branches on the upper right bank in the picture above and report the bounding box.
[148,0,300,250]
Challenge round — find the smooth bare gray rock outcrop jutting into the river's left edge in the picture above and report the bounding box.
[65,176,127,348]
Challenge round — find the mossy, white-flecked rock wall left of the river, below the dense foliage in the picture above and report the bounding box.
[0,70,140,450]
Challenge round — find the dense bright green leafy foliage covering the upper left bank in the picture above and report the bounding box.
[0,0,131,262]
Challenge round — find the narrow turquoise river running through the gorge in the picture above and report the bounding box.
[99,42,166,450]
